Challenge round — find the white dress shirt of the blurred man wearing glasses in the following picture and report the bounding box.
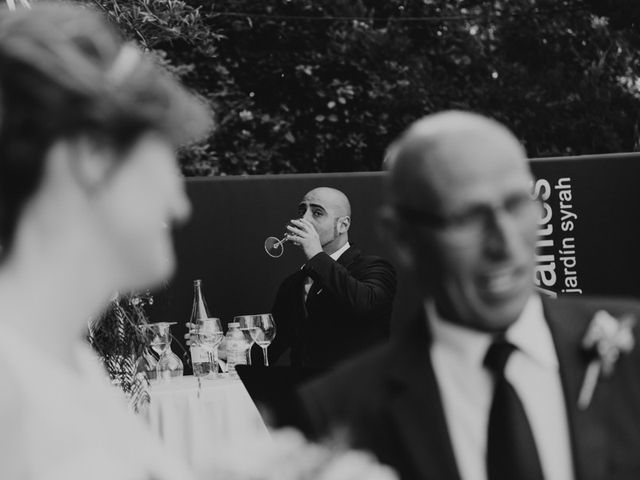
[426,295,574,480]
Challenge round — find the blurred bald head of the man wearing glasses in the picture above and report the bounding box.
[387,111,540,331]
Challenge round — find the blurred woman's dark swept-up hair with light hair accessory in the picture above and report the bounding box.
[0,2,212,256]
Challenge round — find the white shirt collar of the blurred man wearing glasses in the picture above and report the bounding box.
[425,295,558,369]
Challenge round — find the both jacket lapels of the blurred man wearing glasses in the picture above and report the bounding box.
[386,298,610,480]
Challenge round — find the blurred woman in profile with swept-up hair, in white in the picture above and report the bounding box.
[0,3,210,480]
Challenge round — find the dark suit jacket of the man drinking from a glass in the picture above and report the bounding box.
[269,246,396,368]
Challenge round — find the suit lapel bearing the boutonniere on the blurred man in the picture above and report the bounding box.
[543,298,609,480]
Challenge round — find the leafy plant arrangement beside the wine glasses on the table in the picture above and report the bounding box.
[88,291,153,413]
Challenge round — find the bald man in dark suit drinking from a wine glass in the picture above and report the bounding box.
[269,187,396,369]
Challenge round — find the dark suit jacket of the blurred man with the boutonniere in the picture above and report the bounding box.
[300,297,640,480]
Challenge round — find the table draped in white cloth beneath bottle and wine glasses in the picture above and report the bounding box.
[145,376,270,473]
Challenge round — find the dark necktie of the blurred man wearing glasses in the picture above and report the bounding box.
[484,339,544,480]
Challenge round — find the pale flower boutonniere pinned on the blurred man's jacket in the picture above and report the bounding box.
[578,310,636,410]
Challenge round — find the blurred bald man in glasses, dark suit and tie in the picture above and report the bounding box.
[301,112,640,480]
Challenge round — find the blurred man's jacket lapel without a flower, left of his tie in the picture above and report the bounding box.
[387,314,460,479]
